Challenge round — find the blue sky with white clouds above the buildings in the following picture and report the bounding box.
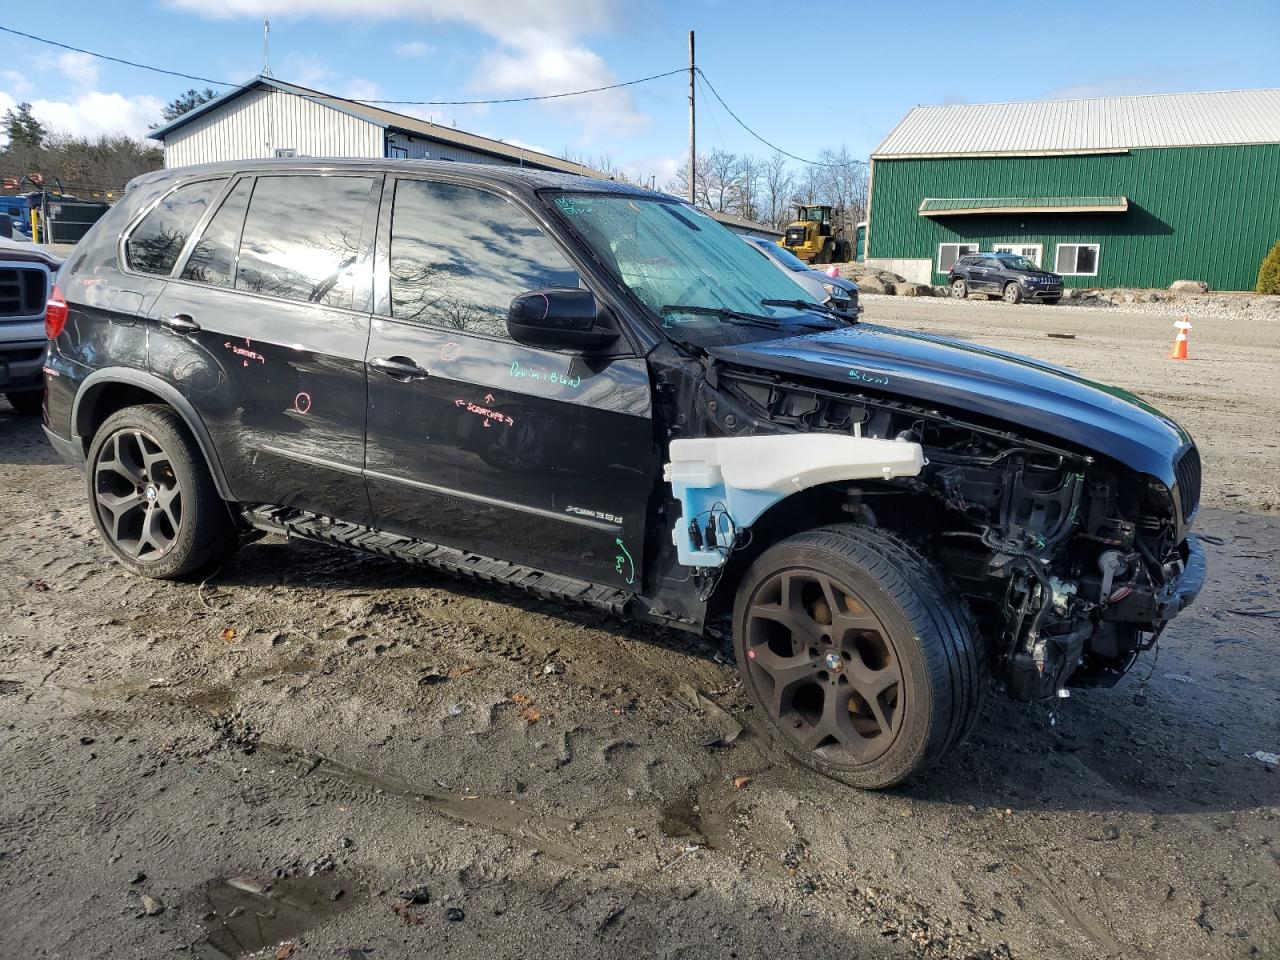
[0,0,1280,186]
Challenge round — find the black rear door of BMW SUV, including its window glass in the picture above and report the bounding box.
[150,172,383,522]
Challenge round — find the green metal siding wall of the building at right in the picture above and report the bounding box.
[868,145,1280,291]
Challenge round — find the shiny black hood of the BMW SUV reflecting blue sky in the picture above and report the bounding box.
[708,324,1190,488]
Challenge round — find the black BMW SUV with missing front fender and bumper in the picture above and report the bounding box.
[37,160,1204,787]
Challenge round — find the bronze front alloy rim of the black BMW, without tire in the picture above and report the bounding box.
[745,570,906,764]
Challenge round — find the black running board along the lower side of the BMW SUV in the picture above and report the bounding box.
[244,504,635,616]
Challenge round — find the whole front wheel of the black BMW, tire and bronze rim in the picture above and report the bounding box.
[733,524,989,790]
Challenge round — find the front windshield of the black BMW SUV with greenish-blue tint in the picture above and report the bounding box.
[553,193,820,346]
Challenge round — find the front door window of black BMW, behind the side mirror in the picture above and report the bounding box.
[390,180,579,337]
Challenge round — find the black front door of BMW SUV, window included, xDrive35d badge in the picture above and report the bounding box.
[366,179,657,590]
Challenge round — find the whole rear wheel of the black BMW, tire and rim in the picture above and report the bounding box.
[86,404,239,580]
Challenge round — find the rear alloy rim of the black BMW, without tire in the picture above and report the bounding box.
[93,429,182,563]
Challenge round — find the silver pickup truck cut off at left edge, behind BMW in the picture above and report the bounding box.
[0,239,61,416]
